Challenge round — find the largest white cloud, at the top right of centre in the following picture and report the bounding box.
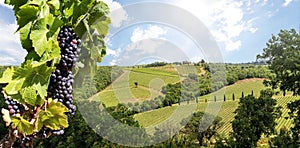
[176,0,246,51]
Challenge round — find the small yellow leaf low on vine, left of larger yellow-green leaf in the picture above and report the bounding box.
[11,117,33,136]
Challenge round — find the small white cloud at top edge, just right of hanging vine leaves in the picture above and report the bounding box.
[102,0,128,28]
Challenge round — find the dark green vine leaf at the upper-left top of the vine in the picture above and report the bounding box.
[16,4,39,30]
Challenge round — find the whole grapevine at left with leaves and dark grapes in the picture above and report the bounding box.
[0,0,110,147]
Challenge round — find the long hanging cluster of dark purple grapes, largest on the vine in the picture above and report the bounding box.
[48,26,81,115]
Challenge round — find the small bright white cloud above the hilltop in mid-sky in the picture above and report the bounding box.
[130,25,167,43]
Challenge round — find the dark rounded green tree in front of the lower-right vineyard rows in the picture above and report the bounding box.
[232,92,281,147]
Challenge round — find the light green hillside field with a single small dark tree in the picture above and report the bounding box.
[91,68,180,106]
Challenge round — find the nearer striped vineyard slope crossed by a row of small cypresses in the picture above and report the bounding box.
[134,79,297,135]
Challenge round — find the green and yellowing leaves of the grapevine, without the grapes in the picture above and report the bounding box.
[0,0,110,145]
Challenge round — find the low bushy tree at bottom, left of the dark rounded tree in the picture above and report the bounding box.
[181,112,223,146]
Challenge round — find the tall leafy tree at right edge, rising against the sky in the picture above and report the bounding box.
[257,29,300,95]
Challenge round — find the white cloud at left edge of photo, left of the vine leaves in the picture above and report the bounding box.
[0,22,26,65]
